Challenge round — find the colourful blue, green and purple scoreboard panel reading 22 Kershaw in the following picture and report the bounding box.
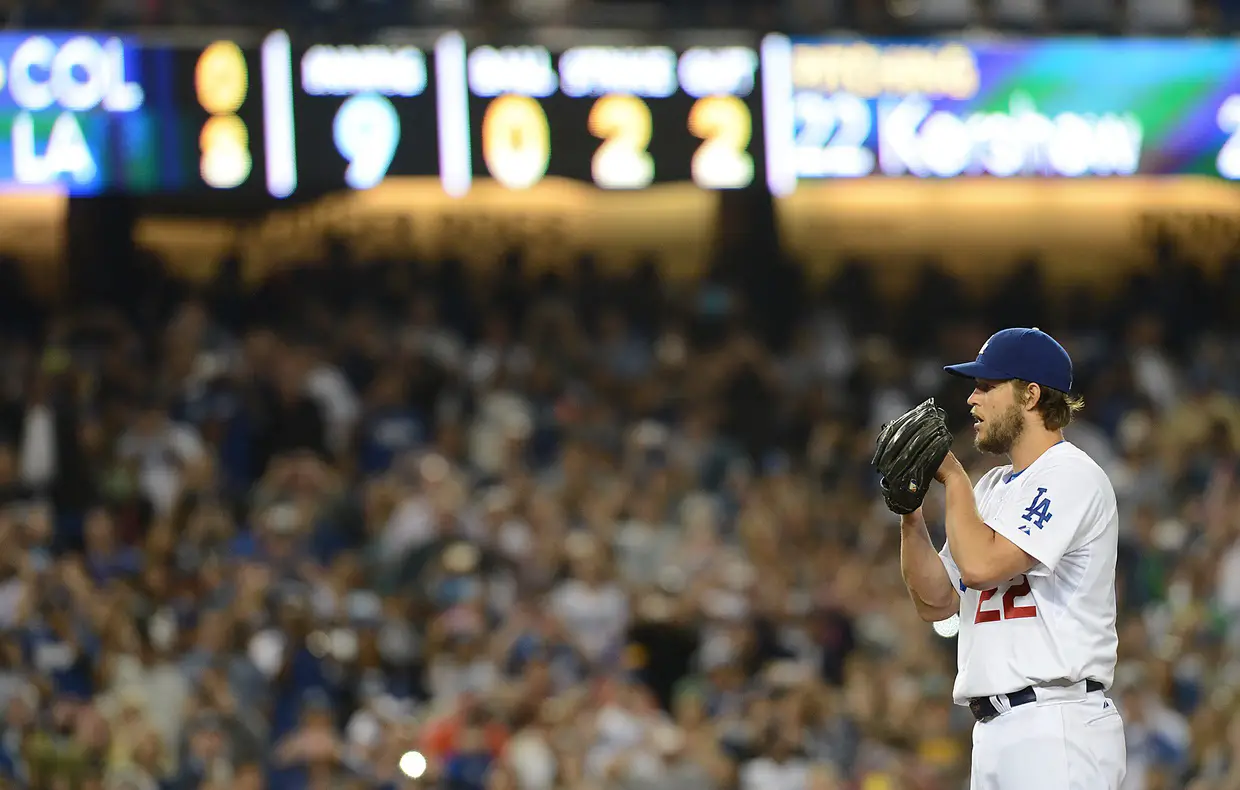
[782,40,1240,184]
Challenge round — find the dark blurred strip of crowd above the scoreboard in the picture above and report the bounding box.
[7,0,1240,36]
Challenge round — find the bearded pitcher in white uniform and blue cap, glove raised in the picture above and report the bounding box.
[875,329,1126,790]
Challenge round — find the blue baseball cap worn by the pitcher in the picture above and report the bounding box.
[942,327,1073,392]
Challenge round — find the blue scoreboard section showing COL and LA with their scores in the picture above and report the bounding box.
[0,33,269,195]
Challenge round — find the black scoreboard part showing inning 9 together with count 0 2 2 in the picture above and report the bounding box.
[263,32,763,197]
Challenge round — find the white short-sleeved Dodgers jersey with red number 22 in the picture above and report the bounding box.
[939,442,1120,704]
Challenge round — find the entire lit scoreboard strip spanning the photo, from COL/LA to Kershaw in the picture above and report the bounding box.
[12,31,1240,198]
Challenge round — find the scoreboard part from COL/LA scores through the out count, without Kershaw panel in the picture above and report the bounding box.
[0,31,765,197]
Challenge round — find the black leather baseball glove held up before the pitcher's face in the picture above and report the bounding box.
[870,398,951,516]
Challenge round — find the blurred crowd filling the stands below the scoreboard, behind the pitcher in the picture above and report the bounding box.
[0,228,1240,790]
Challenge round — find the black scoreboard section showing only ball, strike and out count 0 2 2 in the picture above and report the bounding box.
[467,46,764,190]
